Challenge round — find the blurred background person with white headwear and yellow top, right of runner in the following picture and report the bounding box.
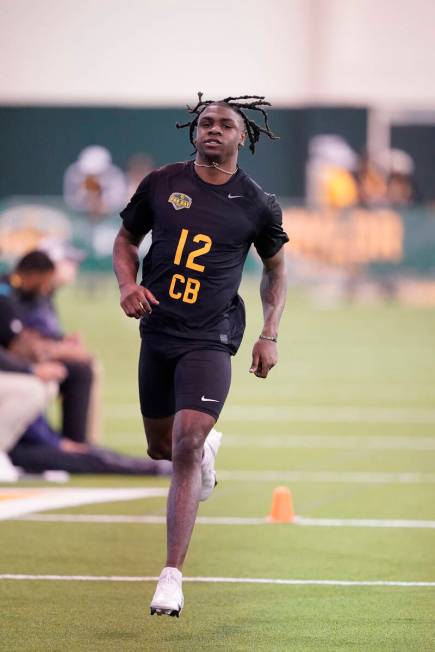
[306,134,359,209]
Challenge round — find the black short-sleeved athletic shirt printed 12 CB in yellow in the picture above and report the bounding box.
[121,161,288,353]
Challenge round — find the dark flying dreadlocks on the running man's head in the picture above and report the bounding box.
[175,92,279,154]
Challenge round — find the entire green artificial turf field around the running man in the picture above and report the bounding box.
[0,280,435,652]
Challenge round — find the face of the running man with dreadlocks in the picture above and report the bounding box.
[196,104,245,163]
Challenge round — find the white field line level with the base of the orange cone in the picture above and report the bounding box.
[14,514,435,529]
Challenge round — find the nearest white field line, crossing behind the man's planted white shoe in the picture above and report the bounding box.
[0,573,435,587]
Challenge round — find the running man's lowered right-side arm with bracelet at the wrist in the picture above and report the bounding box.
[249,247,287,378]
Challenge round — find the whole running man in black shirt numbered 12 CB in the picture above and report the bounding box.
[113,93,288,616]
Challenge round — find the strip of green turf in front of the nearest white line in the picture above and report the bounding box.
[3,582,433,652]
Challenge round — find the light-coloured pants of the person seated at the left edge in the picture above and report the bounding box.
[0,371,57,453]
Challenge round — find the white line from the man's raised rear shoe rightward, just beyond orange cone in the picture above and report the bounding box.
[218,469,435,484]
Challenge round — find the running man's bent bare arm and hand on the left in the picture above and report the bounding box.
[113,226,159,319]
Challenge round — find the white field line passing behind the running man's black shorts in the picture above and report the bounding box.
[104,403,435,423]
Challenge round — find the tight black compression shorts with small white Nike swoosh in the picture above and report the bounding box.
[139,335,231,420]
